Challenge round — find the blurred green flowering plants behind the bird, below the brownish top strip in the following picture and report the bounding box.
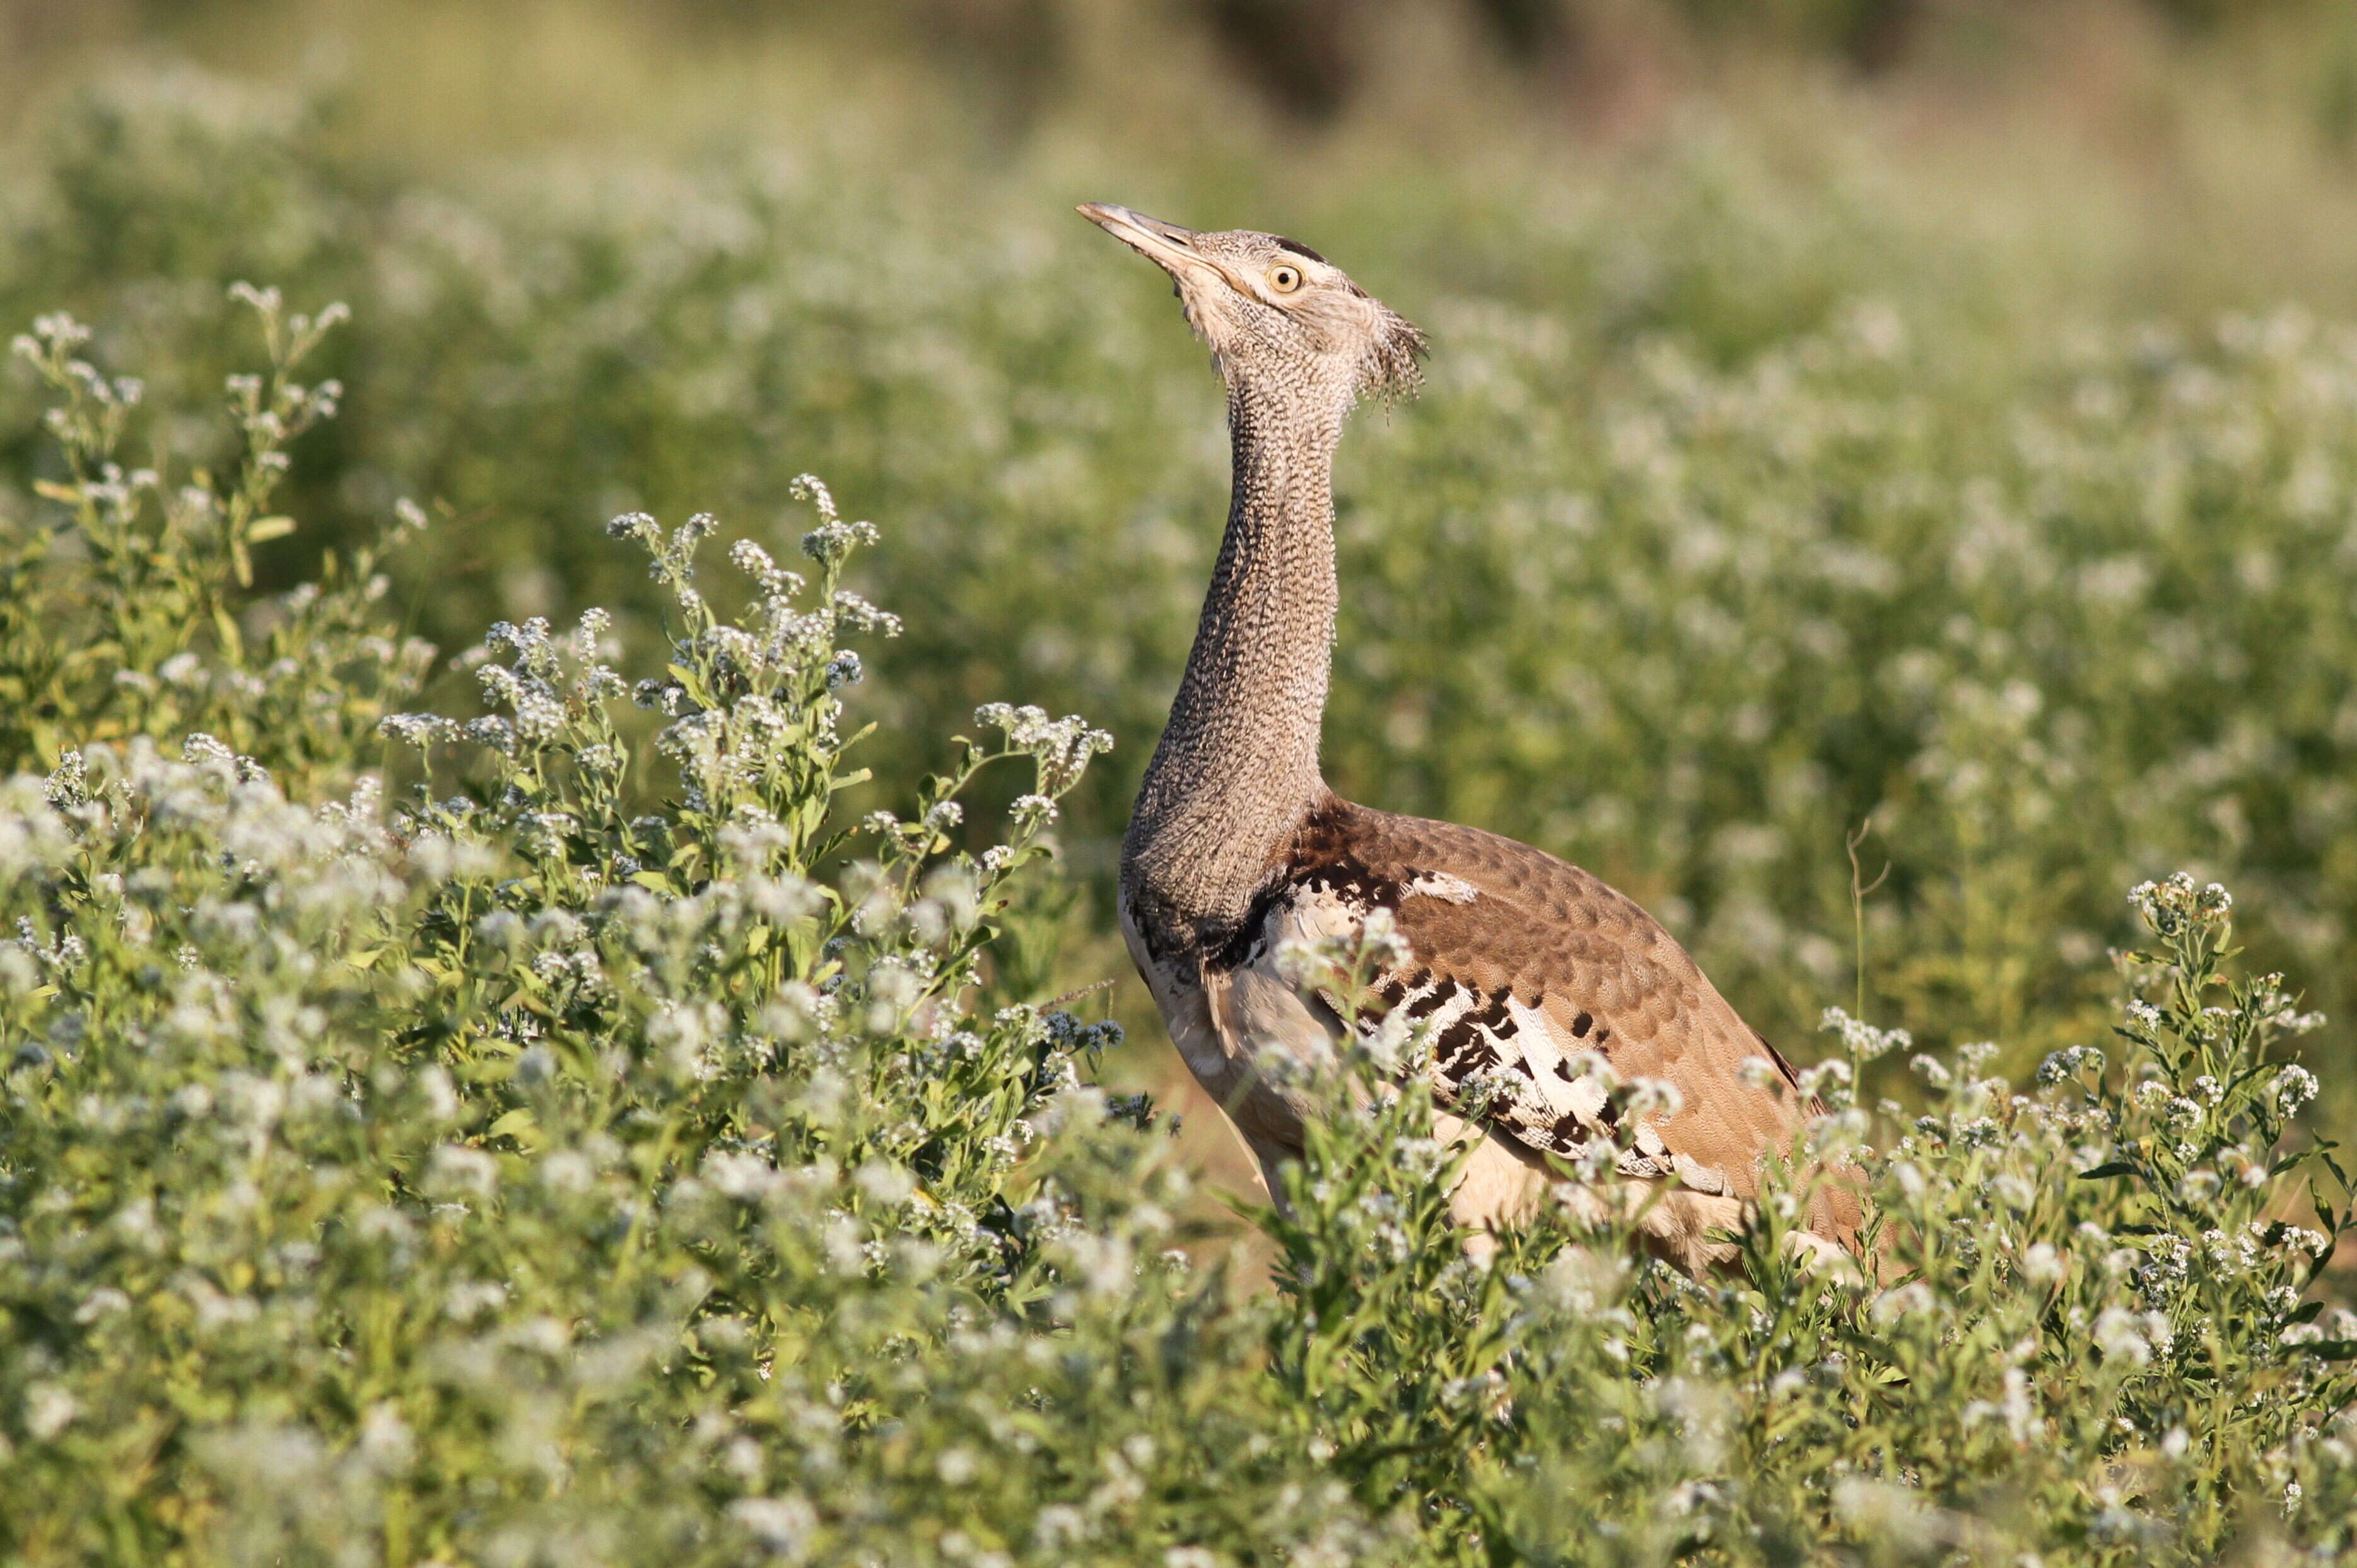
[13,55,2357,1099]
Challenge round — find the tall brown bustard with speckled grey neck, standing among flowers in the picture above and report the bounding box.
[1080,202,1859,1278]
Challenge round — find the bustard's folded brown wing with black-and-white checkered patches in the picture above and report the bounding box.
[1214,799,1855,1231]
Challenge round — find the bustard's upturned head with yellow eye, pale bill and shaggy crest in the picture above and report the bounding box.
[1080,202,1424,406]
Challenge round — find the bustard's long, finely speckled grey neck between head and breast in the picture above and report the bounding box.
[1122,387,1343,943]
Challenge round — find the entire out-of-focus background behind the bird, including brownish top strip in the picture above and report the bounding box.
[0,0,2357,1198]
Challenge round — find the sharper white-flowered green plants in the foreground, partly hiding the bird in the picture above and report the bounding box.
[0,290,2357,1565]
